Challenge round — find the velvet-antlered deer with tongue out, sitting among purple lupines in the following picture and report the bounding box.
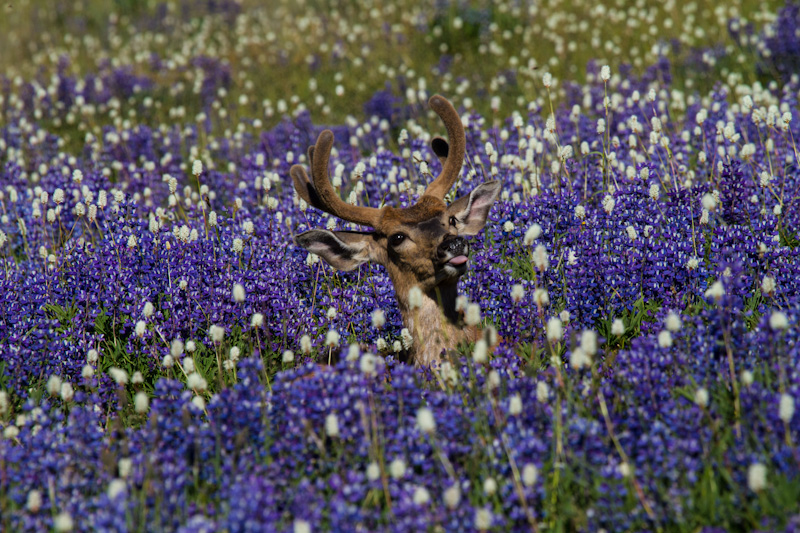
[290,95,500,365]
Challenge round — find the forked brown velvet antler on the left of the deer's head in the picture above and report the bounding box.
[289,130,381,227]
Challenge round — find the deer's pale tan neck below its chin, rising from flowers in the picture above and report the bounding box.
[399,281,478,366]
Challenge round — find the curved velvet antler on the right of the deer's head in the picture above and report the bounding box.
[425,94,467,199]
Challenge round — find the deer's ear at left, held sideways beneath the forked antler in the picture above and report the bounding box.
[295,229,374,270]
